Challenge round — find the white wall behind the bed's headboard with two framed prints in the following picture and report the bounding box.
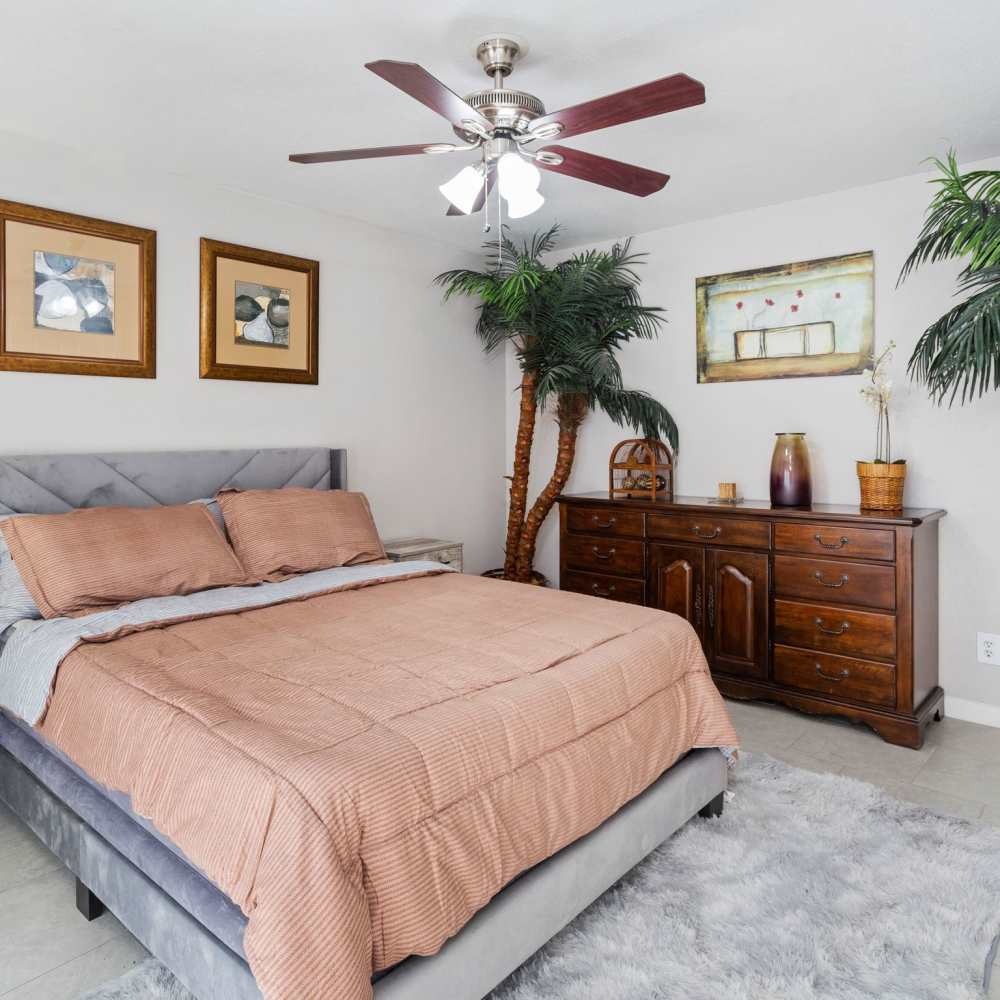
[0,134,504,571]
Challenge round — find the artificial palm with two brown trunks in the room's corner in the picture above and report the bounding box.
[436,226,677,582]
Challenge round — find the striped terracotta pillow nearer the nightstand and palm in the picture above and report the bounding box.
[217,486,385,580]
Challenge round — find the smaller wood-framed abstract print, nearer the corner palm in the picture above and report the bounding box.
[201,239,319,385]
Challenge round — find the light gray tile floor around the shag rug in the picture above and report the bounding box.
[0,702,1000,1000]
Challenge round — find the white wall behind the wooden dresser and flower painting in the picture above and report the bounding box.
[507,159,1000,725]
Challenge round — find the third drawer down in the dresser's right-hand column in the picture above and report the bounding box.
[774,600,896,660]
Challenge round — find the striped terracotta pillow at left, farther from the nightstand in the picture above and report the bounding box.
[0,504,250,618]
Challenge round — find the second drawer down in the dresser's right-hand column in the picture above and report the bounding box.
[774,556,896,611]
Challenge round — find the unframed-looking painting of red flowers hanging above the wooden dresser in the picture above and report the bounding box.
[695,251,875,382]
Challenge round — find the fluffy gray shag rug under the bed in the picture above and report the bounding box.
[81,754,1000,1000]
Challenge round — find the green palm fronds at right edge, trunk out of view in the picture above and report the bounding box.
[899,150,1000,405]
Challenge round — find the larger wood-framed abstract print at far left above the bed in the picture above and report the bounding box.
[0,201,156,378]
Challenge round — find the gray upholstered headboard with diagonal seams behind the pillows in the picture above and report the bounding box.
[0,448,347,514]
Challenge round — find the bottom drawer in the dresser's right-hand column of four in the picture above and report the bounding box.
[773,646,896,708]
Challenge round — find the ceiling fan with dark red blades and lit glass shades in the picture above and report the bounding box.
[289,34,705,228]
